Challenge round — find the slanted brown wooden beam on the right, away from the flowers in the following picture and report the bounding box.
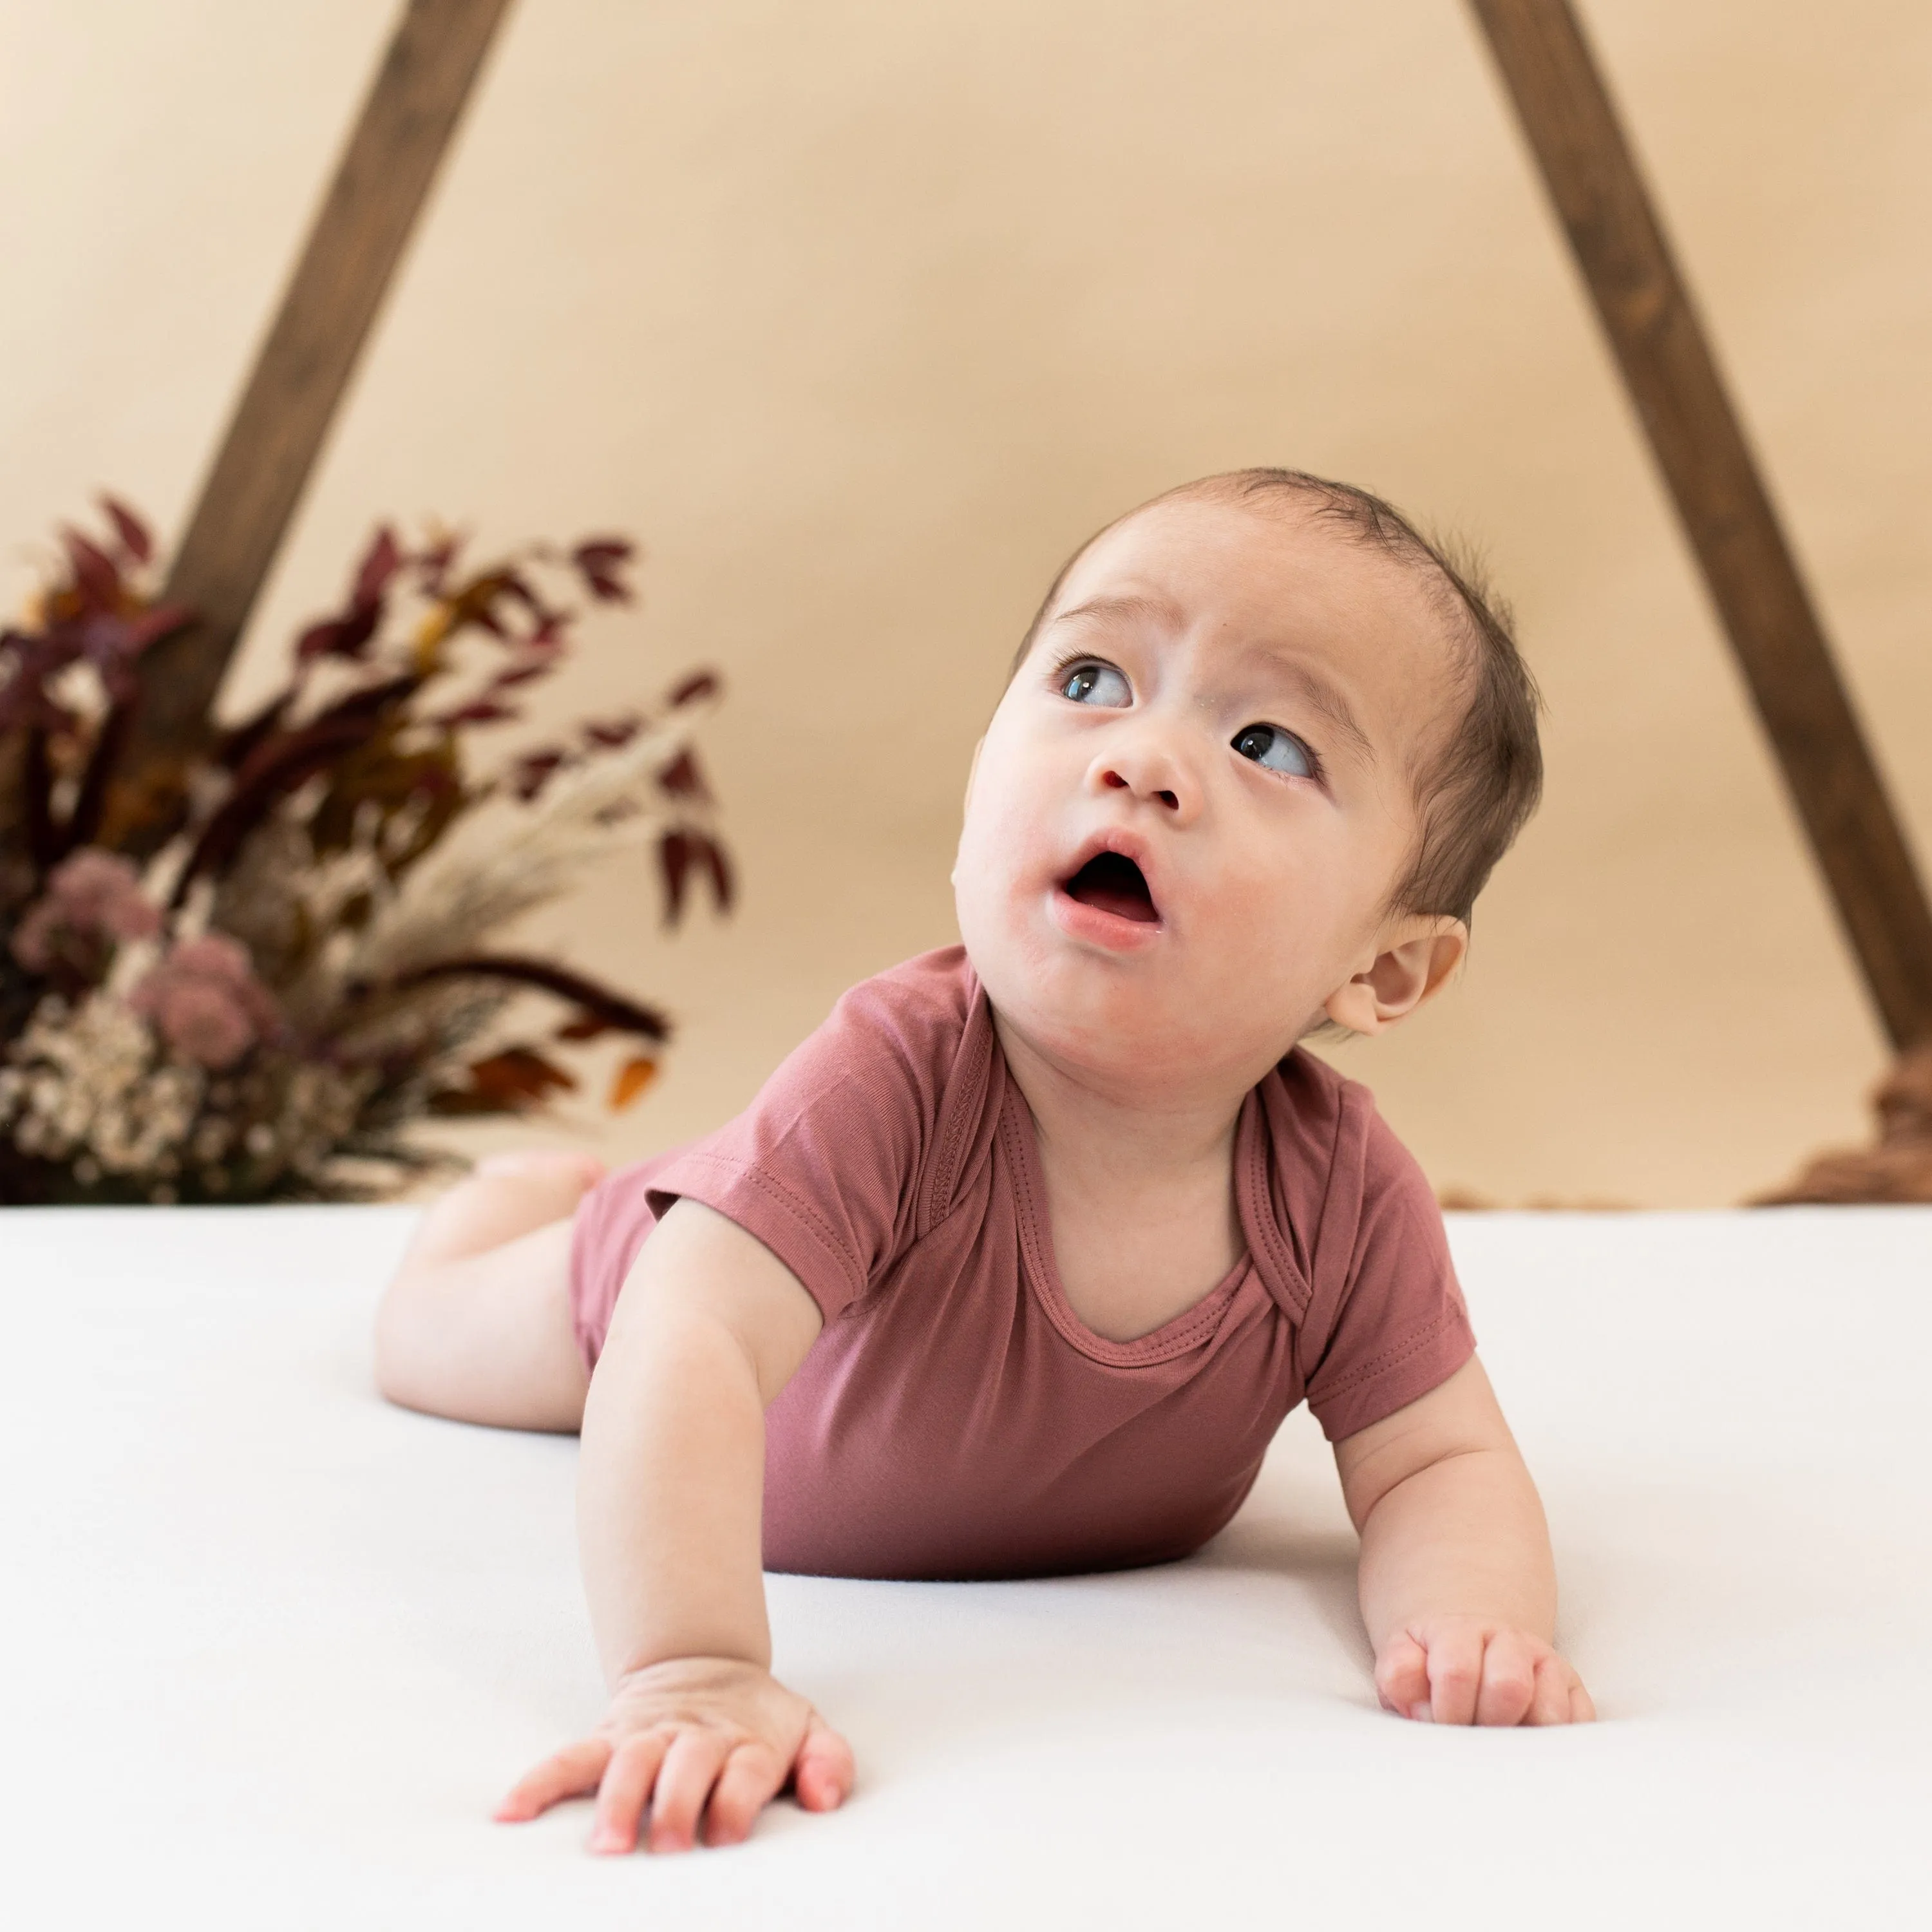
[1470,0,1932,1047]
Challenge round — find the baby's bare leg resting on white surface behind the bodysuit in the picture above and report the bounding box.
[375,1153,603,1432]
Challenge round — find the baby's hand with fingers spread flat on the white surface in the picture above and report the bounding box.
[497,1658,852,1851]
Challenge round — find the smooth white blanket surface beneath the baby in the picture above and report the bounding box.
[0,1209,1932,1932]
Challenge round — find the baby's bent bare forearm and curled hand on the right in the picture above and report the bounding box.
[1335,1360,1596,1723]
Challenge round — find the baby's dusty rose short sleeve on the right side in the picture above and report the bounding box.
[1308,1113,1476,1441]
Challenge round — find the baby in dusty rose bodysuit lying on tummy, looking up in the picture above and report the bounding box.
[377,469,1594,1851]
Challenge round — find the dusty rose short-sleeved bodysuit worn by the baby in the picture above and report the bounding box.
[572,947,1474,1577]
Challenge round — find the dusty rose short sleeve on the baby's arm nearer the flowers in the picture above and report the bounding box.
[649,954,966,1321]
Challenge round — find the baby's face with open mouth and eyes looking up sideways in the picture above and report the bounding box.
[952,498,1455,1086]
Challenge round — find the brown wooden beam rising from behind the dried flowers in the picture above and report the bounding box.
[120,0,510,773]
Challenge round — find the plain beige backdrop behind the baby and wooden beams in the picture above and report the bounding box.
[0,0,1932,1204]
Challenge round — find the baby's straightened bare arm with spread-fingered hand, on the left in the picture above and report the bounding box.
[497,1200,852,1851]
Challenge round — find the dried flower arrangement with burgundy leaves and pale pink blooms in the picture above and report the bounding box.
[0,500,732,1204]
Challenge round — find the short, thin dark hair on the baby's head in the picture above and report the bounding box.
[1014,469,1544,922]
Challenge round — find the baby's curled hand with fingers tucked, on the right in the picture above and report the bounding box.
[1376,1617,1596,1723]
